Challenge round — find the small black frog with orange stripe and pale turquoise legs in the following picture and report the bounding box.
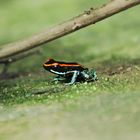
[43,59,98,84]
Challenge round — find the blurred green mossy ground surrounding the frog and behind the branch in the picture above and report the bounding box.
[0,0,140,140]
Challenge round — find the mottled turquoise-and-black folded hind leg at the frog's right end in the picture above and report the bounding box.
[82,69,98,81]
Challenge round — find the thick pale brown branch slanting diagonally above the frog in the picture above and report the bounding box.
[0,0,140,60]
